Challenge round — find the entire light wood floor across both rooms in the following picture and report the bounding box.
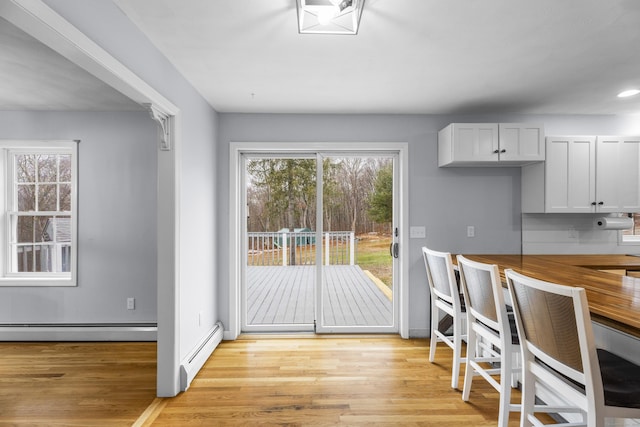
[0,336,536,426]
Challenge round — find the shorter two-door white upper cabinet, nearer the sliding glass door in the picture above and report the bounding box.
[438,123,545,167]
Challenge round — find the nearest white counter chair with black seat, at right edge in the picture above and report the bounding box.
[505,269,640,427]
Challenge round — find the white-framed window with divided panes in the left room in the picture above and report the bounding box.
[0,141,78,286]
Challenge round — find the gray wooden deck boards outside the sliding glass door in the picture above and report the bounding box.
[247,265,393,326]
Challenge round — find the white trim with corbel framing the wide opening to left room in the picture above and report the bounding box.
[0,0,181,396]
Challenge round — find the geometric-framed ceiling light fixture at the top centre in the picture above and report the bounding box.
[296,0,364,34]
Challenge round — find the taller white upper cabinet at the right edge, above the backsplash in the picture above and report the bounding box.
[522,136,640,213]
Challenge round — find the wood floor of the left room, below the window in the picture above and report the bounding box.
[0,342,157,426]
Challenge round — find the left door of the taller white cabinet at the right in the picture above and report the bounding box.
[545,136,596,213]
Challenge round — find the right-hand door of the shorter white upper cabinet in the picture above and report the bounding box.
[499,123,545,163]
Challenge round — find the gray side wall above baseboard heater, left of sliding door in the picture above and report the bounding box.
[44,0,219,360]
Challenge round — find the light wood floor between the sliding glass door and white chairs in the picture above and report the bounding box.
[152,336,540,426]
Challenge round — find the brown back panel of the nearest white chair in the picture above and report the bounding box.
[510,278,583,372]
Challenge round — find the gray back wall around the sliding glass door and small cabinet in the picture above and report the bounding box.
[217,114,640,336]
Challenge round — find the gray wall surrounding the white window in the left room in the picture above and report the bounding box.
[0,111,157,324]
